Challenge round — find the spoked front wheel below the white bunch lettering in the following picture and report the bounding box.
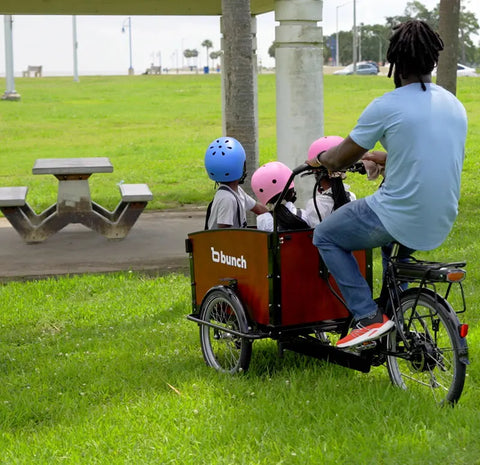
[200,288,252,374]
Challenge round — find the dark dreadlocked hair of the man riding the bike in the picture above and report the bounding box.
[387,20,443,91]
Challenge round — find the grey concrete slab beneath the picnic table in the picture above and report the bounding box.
[0,209,205,281]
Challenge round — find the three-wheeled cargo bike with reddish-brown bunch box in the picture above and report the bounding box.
[186,165,469,404]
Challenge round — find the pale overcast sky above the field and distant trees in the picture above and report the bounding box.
[0,0,480,76]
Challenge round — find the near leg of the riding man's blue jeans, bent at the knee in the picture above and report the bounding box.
[313,199,395,320]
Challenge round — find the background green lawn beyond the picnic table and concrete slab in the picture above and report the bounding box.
[0,74,480,211]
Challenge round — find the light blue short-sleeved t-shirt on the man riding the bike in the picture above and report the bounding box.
[350,83,467,250]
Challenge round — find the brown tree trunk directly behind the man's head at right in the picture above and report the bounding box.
[437,0,460,94]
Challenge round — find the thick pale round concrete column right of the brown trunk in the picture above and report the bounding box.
[275,0,323,203]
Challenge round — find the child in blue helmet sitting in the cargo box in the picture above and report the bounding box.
[205,137,267,229]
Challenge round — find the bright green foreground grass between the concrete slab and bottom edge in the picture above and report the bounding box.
[0,273,480,465]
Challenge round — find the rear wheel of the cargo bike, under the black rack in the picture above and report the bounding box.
[387,289,467,403]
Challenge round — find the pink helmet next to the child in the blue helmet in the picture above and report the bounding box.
[251,161,294,205]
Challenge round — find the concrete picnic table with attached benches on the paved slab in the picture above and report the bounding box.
[0,157,153,243]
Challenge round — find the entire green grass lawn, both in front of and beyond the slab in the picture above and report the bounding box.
[0,75,480,465]
